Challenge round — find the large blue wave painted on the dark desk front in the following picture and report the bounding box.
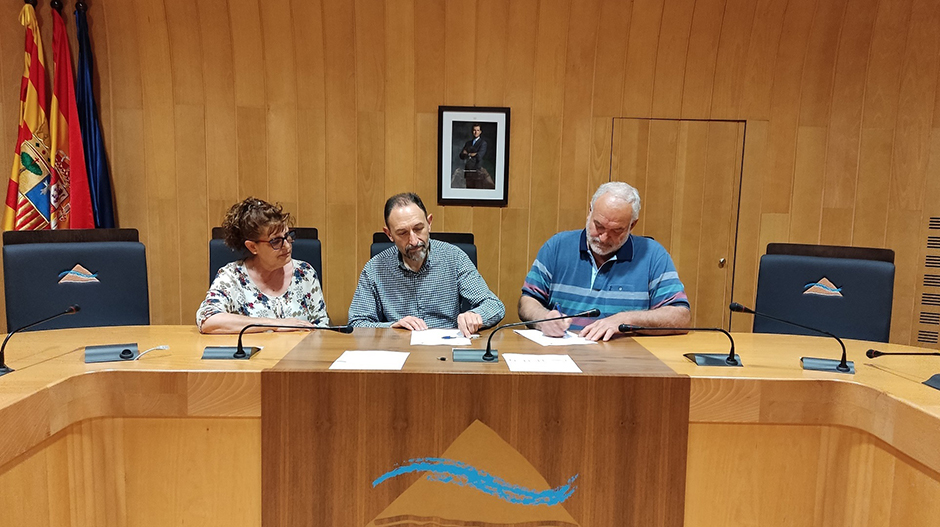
[372,457,578,505]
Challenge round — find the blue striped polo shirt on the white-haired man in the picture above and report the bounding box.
[522,229,690,329]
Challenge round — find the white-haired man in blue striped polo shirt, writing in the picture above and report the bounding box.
[519,181,691,340]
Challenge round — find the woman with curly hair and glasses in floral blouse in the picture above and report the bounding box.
[196,198,330,333]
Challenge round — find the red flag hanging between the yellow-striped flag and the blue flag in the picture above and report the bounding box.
[49,9,95,229]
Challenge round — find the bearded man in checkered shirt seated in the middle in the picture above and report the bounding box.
[349,192,506,336]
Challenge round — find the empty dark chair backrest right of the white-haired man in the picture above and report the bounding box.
[754,244,894,342]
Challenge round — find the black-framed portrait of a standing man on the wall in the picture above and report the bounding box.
[437,106,509,207]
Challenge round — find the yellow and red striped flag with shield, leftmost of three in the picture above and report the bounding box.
[3,4,50,231]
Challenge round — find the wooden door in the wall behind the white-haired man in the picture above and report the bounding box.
[610,118,745,328]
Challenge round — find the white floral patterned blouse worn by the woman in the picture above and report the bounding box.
[196,260,330,330]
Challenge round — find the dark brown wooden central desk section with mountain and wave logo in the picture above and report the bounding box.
[261,329,689,527]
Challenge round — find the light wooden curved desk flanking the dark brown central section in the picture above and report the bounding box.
[0,326,940,526]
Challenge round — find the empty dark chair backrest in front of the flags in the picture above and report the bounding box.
[3,229,150,330]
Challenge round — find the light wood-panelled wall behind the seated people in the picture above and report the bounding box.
[0,0,940,342]
